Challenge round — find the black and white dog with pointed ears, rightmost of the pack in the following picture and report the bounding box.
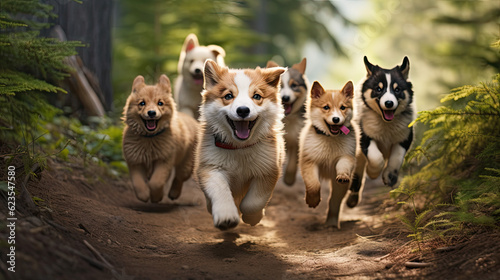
[347,56,416,207]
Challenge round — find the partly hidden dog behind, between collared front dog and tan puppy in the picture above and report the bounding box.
[266,58,309,186]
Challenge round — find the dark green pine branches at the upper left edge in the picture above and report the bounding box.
[0,0,81,142]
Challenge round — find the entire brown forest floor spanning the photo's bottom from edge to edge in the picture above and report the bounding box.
[0,156,500,280]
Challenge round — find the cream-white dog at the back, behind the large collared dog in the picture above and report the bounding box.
[174,34,226,118]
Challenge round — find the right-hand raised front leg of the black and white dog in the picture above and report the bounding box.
[382,129,413,187]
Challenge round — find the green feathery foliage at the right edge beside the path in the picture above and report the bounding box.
[393,69,500,246]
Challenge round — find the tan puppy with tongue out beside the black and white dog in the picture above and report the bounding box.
[299,81,356,229]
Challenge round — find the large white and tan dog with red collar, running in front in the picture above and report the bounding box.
[194,60,286,230]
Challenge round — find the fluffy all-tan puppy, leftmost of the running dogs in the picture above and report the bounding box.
[123,75,198,202]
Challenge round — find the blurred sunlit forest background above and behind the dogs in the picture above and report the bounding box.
[112,0,500,111]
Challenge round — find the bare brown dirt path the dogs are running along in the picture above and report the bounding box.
[10,160,410,279]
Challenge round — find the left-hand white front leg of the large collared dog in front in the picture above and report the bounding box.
[200,171,240,230]
